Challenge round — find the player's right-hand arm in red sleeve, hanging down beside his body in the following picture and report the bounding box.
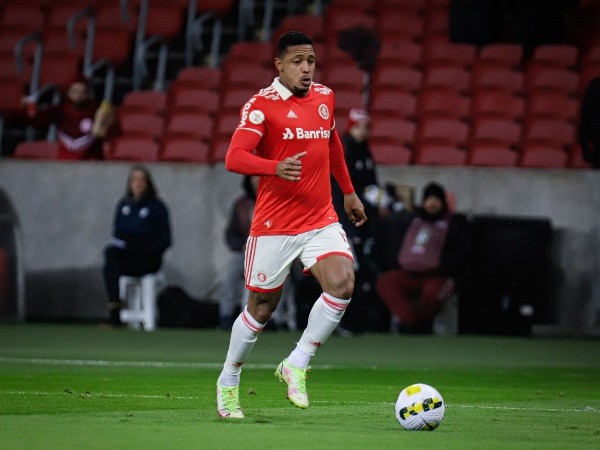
[329,129,367,227]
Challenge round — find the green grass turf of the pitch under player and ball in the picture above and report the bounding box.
[0,324,600,449]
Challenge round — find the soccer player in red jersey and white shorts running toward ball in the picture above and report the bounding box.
[217,31,367,418]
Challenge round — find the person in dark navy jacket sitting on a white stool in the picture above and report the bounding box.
[104,166,171,325]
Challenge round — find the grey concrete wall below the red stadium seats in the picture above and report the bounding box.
[0,159,600,326]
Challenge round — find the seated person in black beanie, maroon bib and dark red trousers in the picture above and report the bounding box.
[377,183,469,332]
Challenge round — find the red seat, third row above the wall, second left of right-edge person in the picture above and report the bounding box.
[471,89,525,121]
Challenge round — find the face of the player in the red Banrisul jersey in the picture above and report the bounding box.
[275,45,316,97]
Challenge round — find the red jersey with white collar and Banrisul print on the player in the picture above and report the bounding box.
[226,79,353,236]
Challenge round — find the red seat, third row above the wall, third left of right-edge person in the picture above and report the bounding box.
[417,86,471,120]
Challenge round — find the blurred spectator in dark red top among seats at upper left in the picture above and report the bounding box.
[24,78,114,160]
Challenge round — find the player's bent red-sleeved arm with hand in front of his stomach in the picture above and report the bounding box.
[225,129,306,181]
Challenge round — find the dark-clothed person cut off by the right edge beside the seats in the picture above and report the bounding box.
[579,77,600,169]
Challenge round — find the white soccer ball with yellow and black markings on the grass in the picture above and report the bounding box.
[396,383,446,431]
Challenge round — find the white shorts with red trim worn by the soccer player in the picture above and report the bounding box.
[244,222,354,292]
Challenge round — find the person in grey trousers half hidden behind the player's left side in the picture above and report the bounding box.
[219,175,259,330]
